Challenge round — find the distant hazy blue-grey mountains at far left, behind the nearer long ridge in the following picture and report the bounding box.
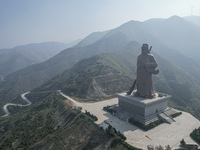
[0,41,78,78]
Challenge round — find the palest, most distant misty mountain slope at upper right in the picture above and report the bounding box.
[144,16,200,63]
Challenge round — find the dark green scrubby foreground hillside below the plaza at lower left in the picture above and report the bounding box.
[0,92,141,150]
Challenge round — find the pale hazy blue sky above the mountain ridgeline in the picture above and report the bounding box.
[0,0,200,48]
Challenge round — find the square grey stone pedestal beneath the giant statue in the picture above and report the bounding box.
[117,93,171,125]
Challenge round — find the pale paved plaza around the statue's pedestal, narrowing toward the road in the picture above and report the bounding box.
[59,91,200,149]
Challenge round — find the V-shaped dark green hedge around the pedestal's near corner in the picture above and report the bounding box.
[129,118,164,131]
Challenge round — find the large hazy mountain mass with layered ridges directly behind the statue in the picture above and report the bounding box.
[0,16,200,118]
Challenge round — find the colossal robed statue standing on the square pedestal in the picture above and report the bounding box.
[127,44,159,98]
